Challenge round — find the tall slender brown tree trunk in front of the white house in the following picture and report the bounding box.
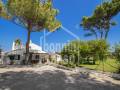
[25,27,31,64]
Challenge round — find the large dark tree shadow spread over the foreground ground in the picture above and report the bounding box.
[0,70,120,90]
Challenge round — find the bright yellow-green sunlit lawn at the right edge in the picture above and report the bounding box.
[80,59,118,72]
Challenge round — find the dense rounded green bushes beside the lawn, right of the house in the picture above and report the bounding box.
[61,40,109,65]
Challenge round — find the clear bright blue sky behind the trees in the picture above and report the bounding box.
[0,0,120,51]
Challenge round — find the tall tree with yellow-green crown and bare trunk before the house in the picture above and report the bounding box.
[7,0,61,63]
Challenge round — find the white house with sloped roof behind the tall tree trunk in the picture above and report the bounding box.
[3,40,62,64]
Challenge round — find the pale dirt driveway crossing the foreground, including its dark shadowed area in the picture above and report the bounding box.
[0,65,120,90]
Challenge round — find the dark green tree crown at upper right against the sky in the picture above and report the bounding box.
[81,0,120,39]
